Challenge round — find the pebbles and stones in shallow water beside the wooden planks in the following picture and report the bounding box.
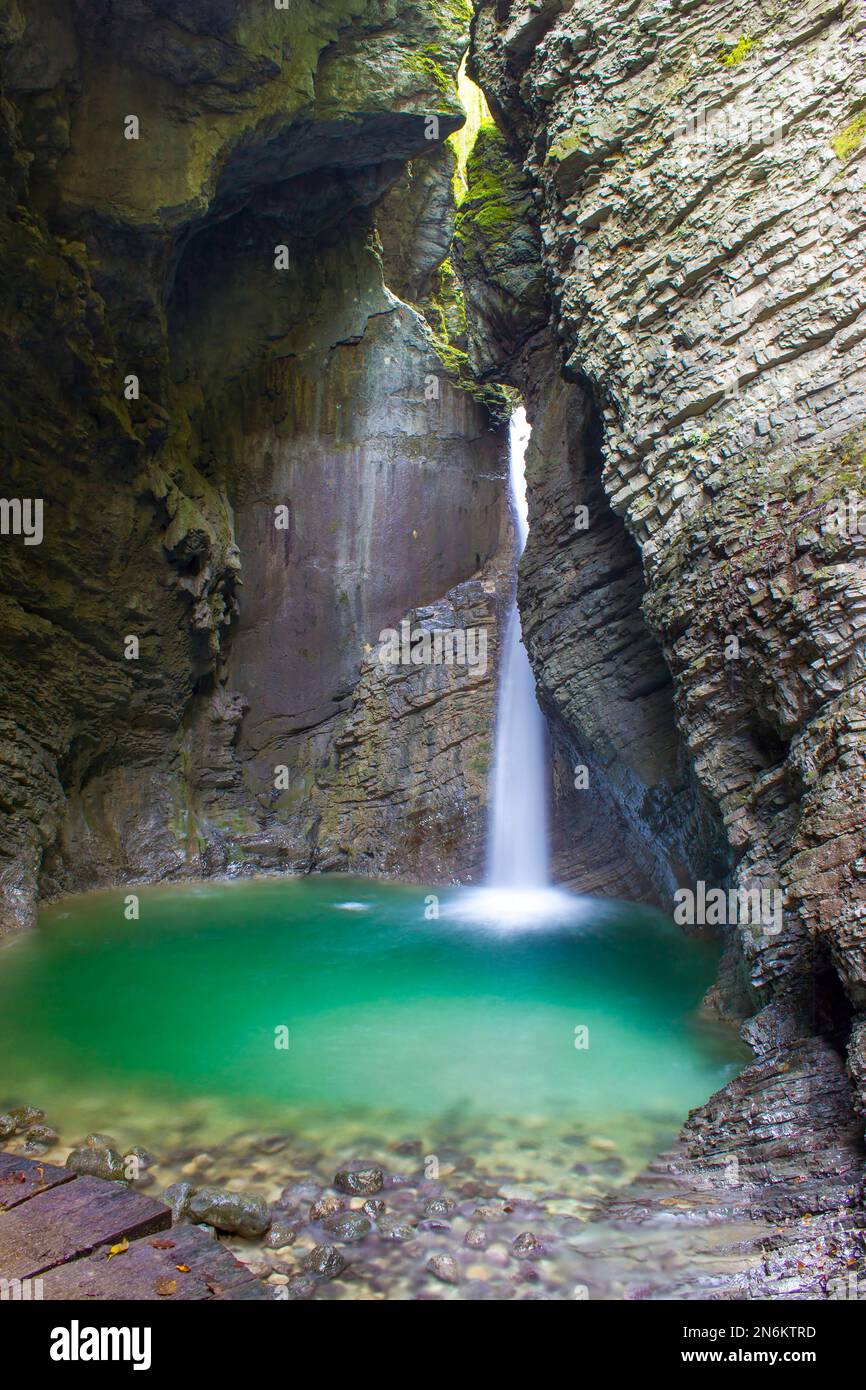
[0,1102,686,1300]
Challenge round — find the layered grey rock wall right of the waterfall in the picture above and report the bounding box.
[473,0,866,1293]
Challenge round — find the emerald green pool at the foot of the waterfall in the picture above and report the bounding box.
[0,876,742,1180]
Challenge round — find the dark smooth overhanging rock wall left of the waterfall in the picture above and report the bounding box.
[0,0,507,930]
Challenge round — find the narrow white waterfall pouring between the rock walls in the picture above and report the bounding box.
[488,407,550,890]
